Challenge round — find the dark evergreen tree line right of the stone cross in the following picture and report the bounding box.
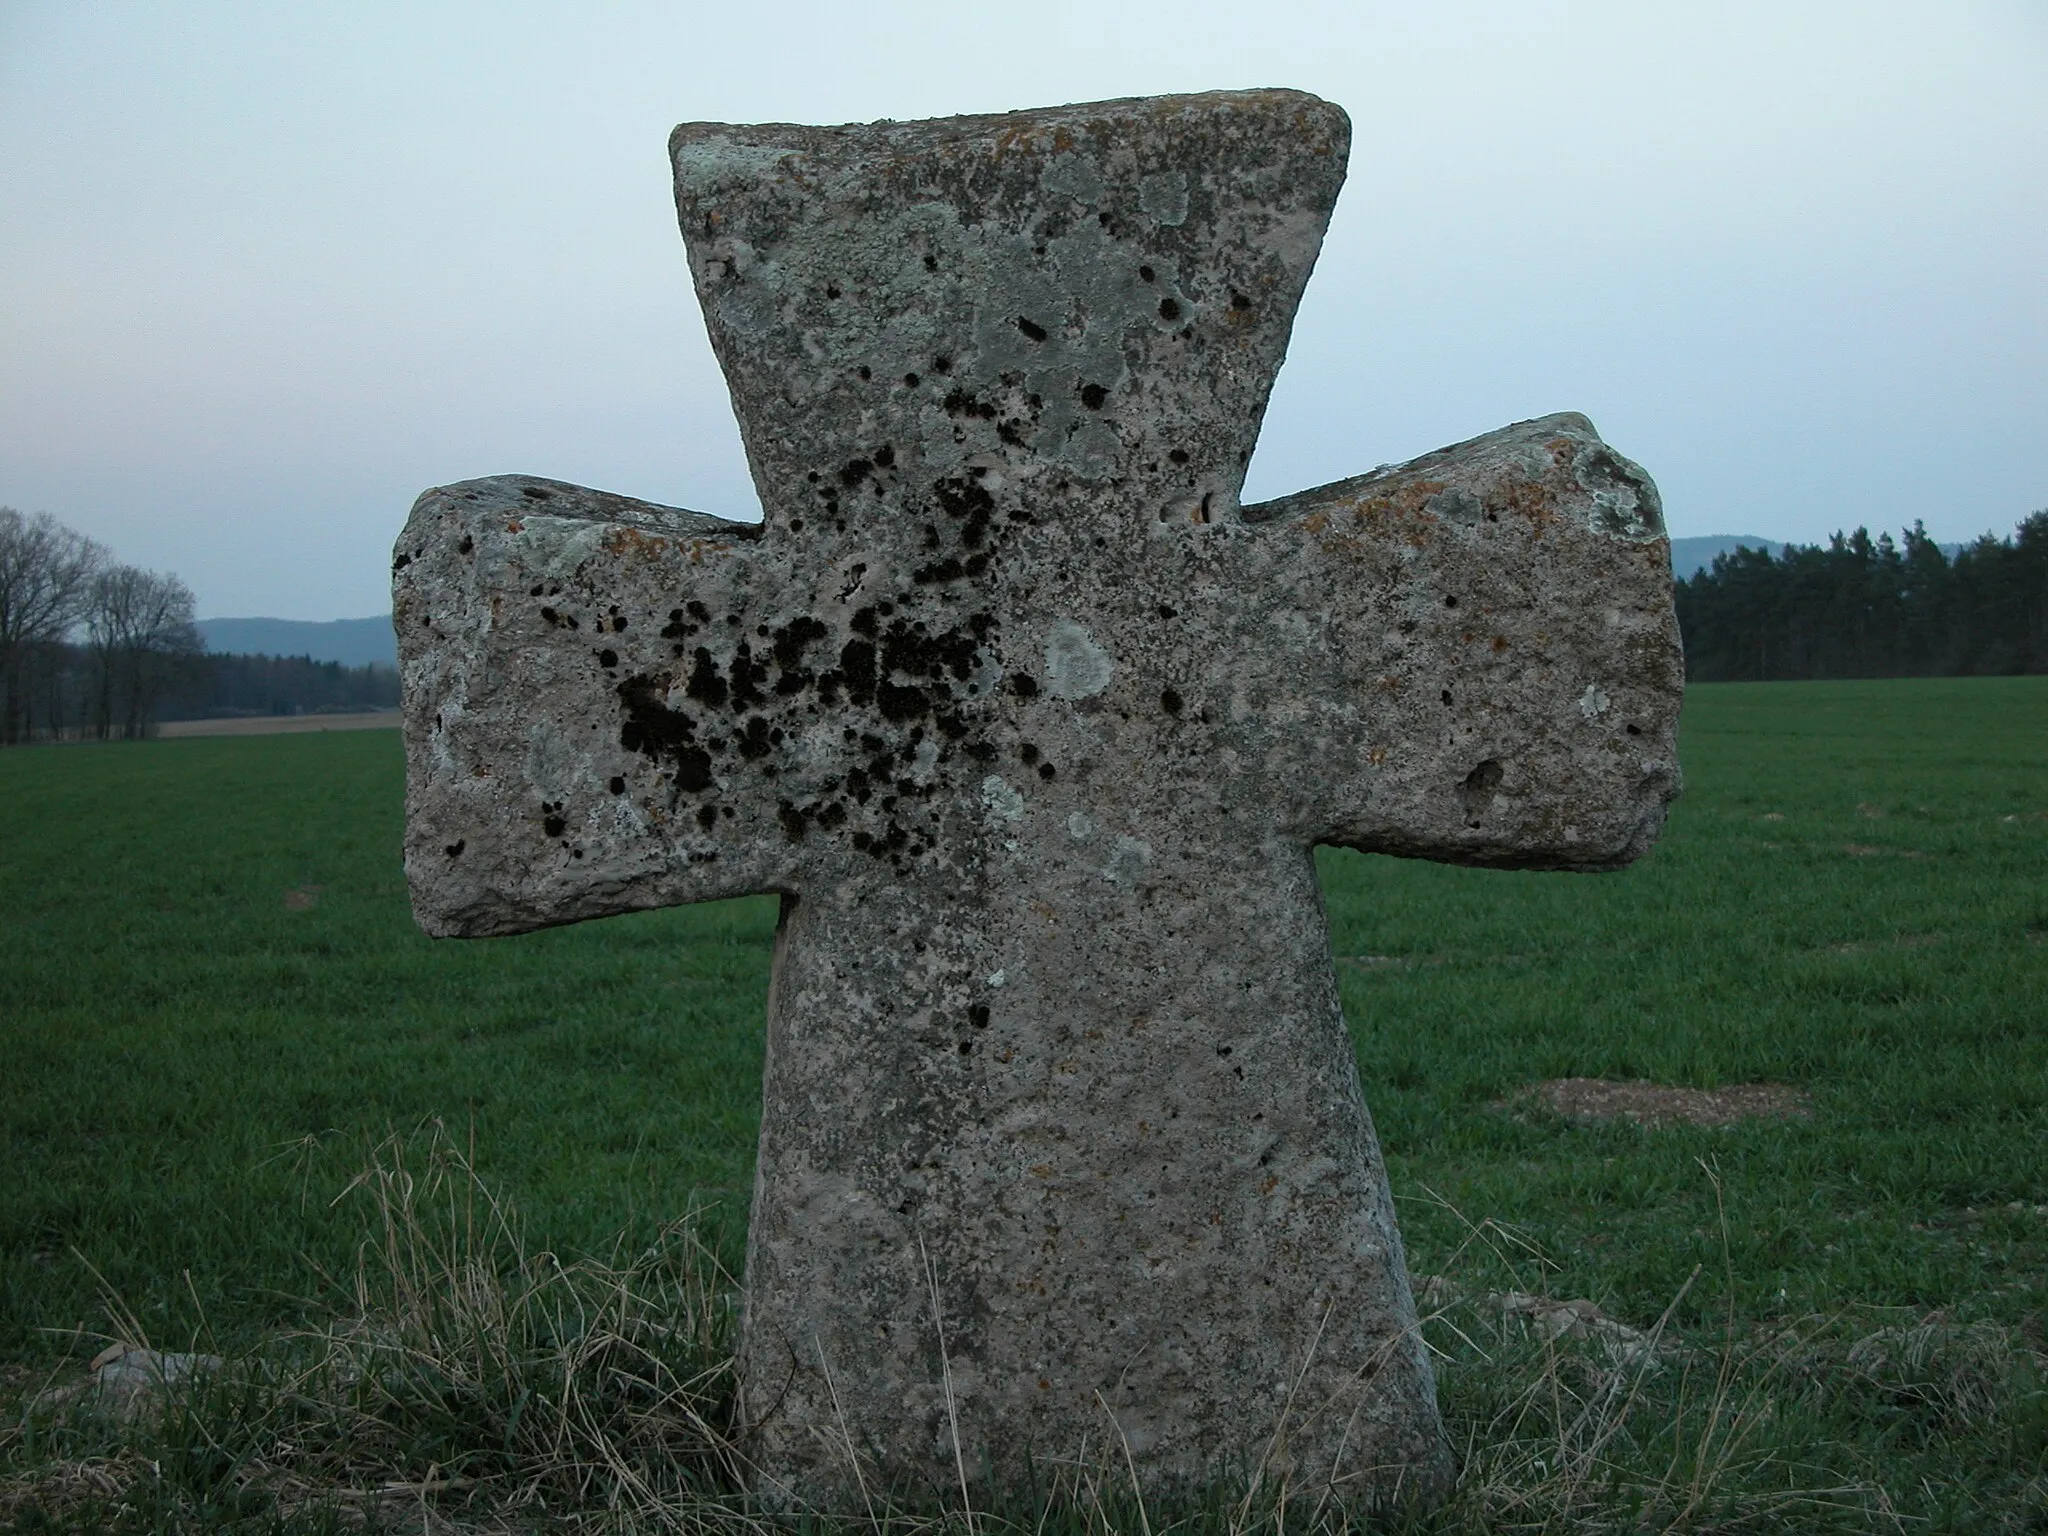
[1675,510,2048,682]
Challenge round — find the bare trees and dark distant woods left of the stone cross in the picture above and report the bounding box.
[0,508,397,745]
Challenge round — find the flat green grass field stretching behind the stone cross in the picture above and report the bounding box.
[0,678,2048,1530]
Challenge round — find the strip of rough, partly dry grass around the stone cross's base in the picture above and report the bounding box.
[0,1124,2048,1536]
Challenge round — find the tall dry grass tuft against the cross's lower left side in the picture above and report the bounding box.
[276,1124,753,1530]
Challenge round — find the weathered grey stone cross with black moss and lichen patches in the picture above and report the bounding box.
[393,90,1681,1507]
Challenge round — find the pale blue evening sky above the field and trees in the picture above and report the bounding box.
[0,0,2048,618]
